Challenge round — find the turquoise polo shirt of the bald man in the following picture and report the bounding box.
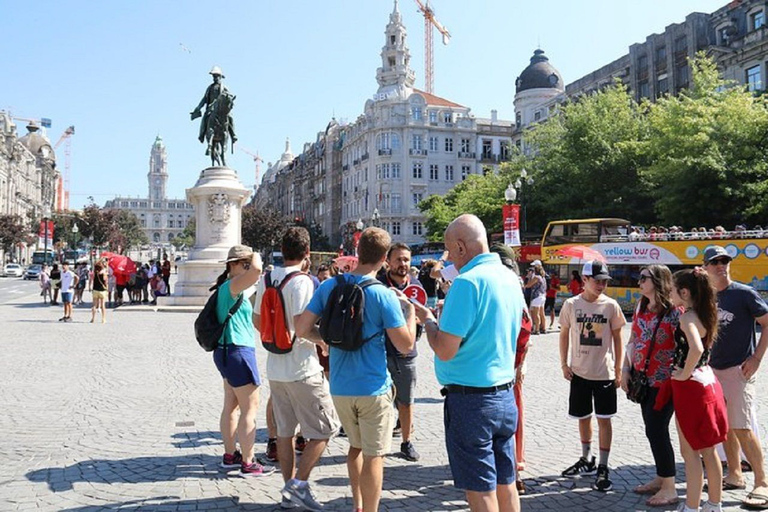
[435,253,525,388]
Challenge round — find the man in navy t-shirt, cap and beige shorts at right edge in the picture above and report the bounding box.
[704,245,768,509]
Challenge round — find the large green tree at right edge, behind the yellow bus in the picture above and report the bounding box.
[647,53,768,227]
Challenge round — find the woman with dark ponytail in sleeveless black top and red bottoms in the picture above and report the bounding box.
[672,267,728,512]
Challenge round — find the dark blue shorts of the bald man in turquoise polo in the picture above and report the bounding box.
[443,388,517,492]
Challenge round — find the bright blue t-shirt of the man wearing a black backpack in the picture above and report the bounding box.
[307,274,405,396]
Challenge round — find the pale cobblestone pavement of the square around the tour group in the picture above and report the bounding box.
[0,283,768,512]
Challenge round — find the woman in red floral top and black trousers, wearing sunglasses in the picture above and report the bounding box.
[621,265,680,507]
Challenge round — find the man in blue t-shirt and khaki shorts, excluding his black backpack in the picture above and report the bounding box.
[296,228,416,510]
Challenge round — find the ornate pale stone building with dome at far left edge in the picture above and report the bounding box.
[0,111,59,262]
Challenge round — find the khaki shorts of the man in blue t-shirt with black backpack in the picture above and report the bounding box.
[333,388,394,457]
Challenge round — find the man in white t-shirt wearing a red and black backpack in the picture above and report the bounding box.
[254,227,340,511]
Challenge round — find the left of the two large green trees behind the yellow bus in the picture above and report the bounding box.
[518,83,654,231]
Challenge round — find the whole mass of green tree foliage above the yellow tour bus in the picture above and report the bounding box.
[420,54,768,234]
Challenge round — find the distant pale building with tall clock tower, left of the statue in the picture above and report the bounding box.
[104,135,195,249]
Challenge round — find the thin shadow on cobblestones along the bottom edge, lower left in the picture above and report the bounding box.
[62,496,281,512]
